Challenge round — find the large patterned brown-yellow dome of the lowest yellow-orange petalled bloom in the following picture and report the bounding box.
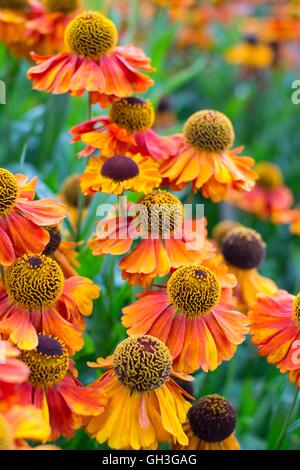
[114,335,172,392]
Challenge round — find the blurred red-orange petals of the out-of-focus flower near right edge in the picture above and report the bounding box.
[229,186,294,220]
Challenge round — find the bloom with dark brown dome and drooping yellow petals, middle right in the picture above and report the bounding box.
[221,226,277,311]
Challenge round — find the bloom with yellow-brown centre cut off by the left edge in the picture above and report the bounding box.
[0,168,66,266]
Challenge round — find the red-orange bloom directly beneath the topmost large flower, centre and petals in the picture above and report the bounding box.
[70,96,178,161]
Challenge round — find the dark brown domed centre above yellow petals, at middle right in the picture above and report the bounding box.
[222,227,266,269]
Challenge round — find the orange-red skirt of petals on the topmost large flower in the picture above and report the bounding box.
[27,46,154,104]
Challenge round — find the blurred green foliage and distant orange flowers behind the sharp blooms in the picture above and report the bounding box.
[0,0,300,449]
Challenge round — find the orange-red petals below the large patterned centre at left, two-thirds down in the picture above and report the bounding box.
[0,277,100,354]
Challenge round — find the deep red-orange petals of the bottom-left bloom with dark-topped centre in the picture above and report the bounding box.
[21,375,107,440]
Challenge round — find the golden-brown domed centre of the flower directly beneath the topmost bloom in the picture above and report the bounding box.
[110,96,155,133]
